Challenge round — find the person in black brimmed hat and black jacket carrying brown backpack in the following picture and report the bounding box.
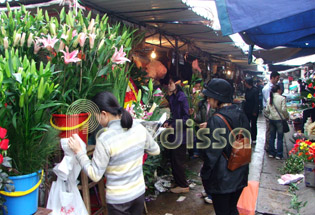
[200,78,249,215]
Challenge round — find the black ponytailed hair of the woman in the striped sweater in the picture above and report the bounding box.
[93,91,133,129]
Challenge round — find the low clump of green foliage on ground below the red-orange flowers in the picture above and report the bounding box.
[280,155,304,174]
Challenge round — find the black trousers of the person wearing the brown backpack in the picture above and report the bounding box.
[211,188,243,215]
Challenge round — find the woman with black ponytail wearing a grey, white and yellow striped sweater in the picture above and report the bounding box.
[68,92,160,215]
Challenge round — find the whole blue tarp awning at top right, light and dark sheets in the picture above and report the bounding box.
[216,0,315,49]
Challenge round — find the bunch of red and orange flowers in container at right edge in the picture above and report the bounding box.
[289,139,315,187]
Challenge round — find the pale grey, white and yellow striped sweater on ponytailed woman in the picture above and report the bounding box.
[76,120,160,204]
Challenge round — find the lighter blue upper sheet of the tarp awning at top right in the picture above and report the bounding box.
[215,0,315,35]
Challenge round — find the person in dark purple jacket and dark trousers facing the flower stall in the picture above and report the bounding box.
[164,77,190,193]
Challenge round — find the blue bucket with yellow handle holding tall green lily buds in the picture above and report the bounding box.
[0,49,60,214]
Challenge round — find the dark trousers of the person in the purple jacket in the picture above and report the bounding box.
[170,144,188,187]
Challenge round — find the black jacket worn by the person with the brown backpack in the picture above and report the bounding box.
[201,105,250,194]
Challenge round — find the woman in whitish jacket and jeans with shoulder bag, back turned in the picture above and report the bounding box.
[265,85,289,160]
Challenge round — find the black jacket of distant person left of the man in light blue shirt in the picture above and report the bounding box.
[244,87,259,116]
